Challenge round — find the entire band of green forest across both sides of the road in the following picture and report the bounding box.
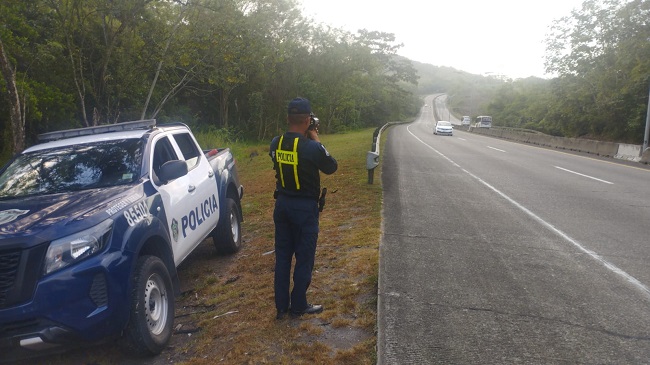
[0,0,650,164]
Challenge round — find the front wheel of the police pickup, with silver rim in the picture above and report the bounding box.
[125,256,175,356]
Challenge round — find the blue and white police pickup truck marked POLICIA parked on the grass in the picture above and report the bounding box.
[0,120,243,360]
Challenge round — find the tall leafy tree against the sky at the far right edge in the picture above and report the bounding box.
[546,0,650,142]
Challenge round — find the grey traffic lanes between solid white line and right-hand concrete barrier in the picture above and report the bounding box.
[430,128,650,282]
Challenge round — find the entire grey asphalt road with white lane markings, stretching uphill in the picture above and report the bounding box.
[378,95,650,364]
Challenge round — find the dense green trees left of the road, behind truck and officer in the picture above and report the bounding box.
[0,0,420,155]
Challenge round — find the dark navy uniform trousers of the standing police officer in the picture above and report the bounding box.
[273,194,319,312]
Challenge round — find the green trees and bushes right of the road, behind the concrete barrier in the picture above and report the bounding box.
[480,0,650,144]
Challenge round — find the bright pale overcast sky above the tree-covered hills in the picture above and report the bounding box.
[298,0,583,79]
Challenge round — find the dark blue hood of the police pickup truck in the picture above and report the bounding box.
[0,185,143,241]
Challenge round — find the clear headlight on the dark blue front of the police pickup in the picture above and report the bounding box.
[43,219,113,275]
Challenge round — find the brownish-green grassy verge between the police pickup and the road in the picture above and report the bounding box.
[185,129,382,365]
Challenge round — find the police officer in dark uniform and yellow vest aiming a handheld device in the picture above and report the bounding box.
[269,98,338,319]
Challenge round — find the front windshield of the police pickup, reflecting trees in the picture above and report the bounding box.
[0,139,142,199]
